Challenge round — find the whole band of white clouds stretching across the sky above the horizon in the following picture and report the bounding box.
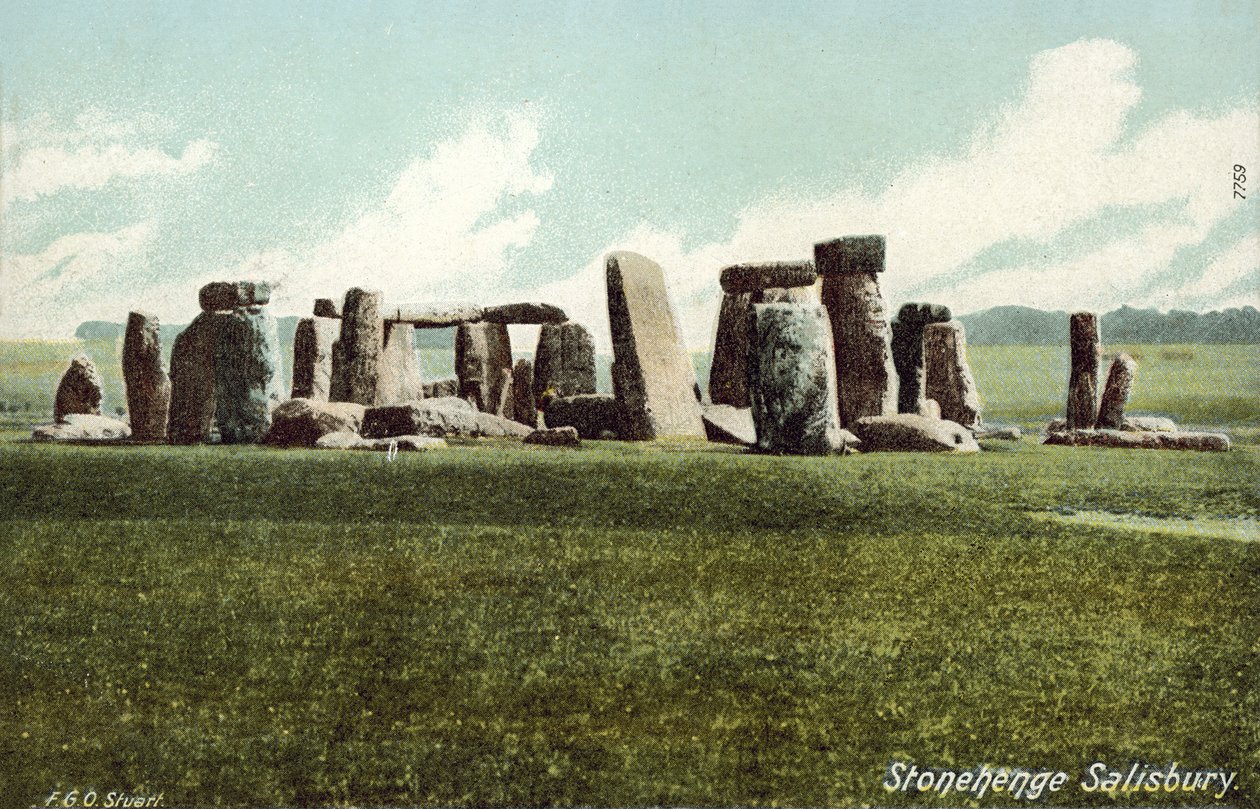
[0,39,1260,349]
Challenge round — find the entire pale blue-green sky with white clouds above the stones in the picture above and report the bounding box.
[0,0,1260,349]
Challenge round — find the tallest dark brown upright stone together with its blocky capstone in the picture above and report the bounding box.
[814,236,897,426]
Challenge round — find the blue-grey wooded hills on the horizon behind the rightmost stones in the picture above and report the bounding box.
[959,306,1260,345]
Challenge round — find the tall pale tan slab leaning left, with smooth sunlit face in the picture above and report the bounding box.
[606,252,704,440]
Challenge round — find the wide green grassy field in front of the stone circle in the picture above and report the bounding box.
[0,430,1260,808]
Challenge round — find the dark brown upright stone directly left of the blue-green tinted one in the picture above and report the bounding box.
[166,311,231,444]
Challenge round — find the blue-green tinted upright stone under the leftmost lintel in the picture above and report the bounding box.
[214,307,284,444]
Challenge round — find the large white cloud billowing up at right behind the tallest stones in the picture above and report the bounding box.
[551,39,1260,348]
